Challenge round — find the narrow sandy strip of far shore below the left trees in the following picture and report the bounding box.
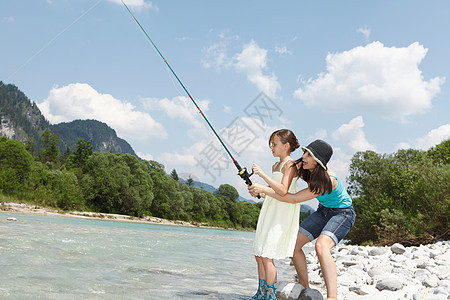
[0,202,216,228]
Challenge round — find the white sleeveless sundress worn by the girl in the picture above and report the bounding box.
[253,162,300,259]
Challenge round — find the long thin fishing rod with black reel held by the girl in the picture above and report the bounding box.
[120,0,261,198]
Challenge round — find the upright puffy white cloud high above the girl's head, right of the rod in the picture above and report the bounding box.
[233,40,281,98]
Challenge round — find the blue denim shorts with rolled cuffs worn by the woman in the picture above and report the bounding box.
[298,204,356,245]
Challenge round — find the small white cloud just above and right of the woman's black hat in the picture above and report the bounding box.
[332,116,376,152]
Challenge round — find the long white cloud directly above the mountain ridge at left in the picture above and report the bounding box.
[38,83,167,139]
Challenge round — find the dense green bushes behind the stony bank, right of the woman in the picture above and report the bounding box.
[346,139,450,245]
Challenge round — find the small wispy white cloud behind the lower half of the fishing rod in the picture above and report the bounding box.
[141,96,209,128]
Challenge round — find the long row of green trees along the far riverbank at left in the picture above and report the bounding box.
[0,131,261,229]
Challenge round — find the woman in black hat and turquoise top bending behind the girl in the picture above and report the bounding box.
[249,140,355,299]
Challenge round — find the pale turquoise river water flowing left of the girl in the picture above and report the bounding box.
[0,213,302,299]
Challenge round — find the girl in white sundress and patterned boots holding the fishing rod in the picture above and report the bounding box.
[252,129,300,300]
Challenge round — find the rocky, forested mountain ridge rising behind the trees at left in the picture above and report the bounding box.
[0,82,137,157]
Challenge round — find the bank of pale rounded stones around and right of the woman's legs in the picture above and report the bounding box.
[278,241,450,300]
